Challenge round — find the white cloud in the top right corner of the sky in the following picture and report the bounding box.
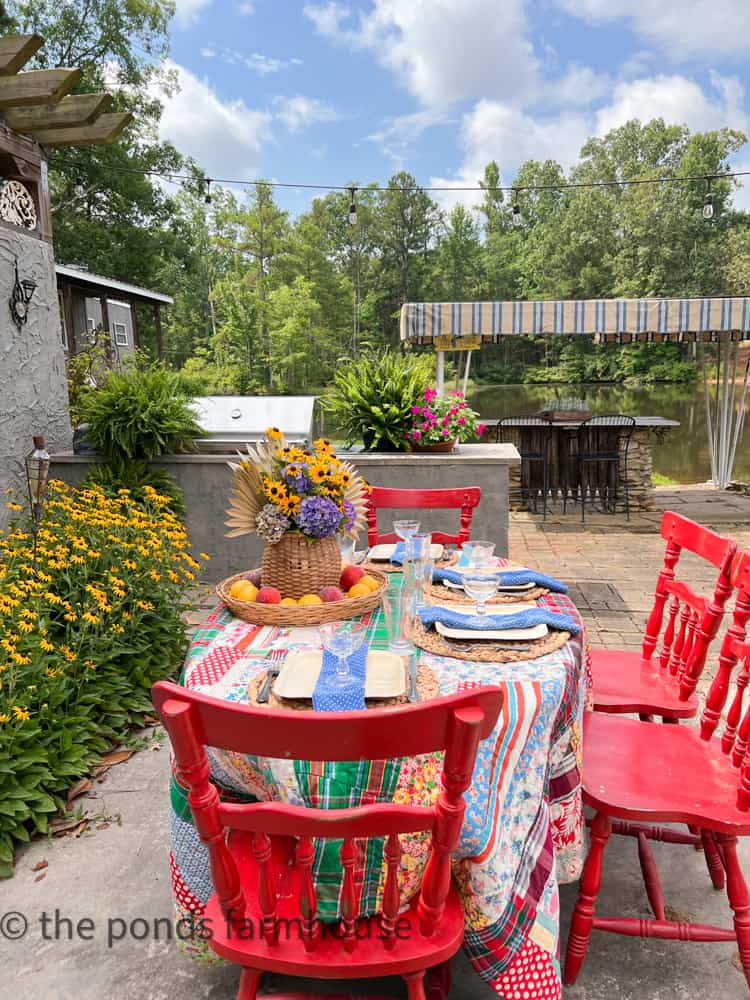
[557,0,750,62]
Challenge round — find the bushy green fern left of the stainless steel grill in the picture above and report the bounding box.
[81,363,201,460]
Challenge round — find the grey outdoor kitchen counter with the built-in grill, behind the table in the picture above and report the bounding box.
[50,444,521,580]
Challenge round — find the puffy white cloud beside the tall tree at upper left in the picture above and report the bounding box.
[156,62,273,180]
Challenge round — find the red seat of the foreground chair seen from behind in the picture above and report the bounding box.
[205,831,464,979]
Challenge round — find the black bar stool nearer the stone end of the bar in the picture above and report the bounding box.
[577,413,635,521]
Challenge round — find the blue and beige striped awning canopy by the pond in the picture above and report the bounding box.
[401,297,750,347]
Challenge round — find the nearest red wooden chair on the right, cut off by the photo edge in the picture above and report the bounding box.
[564,553,750,985]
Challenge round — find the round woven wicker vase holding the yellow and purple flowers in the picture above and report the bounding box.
[260,531,341,598]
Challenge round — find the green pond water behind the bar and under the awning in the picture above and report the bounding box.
[469,383,750,483]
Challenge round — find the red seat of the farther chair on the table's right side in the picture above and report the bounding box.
[591,649,698,719]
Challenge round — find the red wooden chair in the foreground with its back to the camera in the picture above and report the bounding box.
[152,682,502,1000]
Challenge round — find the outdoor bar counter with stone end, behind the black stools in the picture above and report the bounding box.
[482,417,680,510]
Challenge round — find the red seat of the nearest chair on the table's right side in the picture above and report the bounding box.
[583,712,750,837]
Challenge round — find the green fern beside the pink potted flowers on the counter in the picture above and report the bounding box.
[323,350,433,451]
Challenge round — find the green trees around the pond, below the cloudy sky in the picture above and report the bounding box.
[5,0,750,393]
